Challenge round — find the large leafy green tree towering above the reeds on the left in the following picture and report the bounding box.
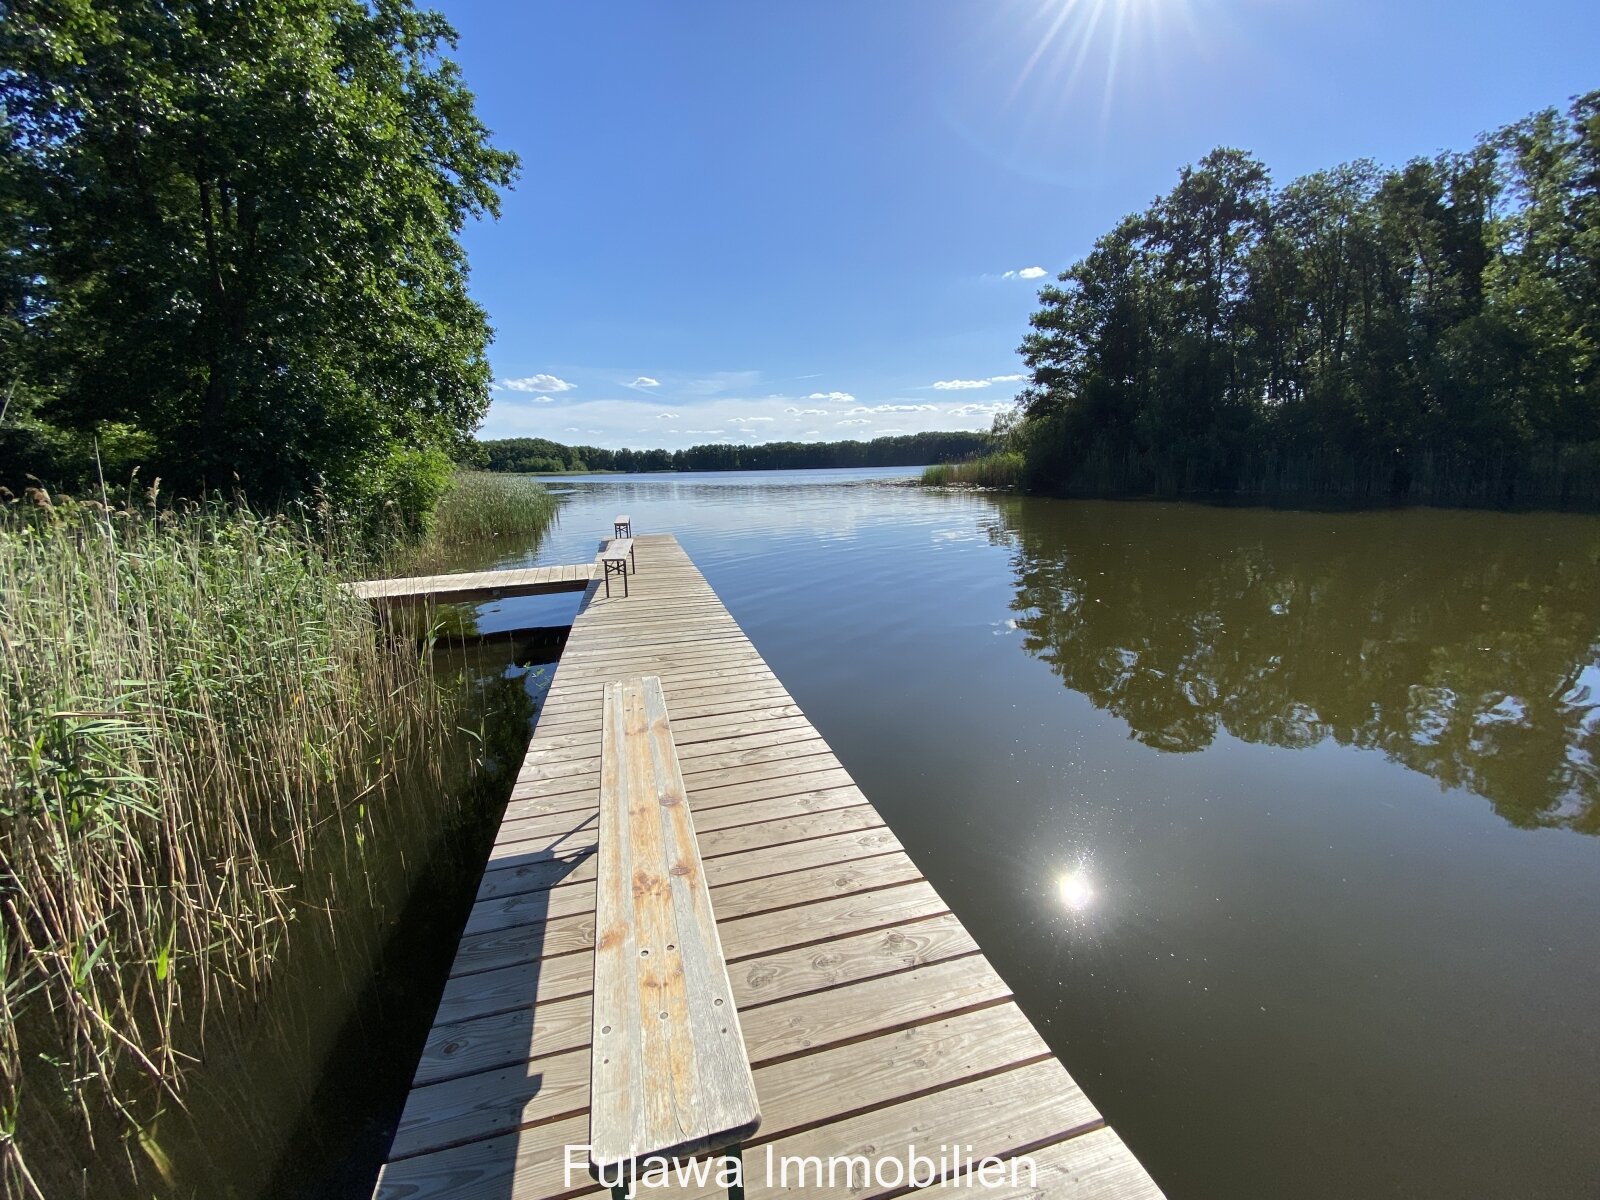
[0,0,515,530]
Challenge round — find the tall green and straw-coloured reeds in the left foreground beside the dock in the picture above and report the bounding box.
[0,483,492,1197]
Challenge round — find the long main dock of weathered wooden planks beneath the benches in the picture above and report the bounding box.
[376,534,1160,1200]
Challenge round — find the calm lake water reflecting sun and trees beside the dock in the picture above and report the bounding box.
[467,470,1600,1200]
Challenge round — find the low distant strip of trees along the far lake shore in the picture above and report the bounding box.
[472,432,990,472]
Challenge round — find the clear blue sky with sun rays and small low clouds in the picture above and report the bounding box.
[435,0,1600,448]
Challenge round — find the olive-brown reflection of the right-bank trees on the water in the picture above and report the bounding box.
[992,498,1600,834]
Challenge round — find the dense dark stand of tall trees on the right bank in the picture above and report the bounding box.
[1011,93,1600,506]
